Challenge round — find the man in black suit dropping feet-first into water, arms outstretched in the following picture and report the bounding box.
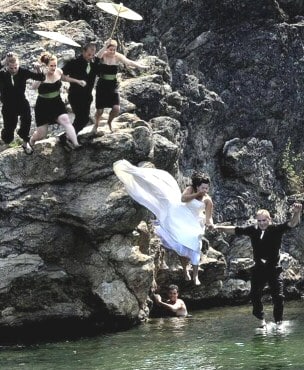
[214,203,302,328]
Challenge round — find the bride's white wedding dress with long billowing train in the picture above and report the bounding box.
[113,160,205,265]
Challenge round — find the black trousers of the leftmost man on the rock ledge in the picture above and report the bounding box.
[1,99,32,144]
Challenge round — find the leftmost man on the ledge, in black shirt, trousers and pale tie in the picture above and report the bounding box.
[0,53,45,154]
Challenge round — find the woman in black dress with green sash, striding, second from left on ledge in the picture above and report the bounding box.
[30,52,86,149]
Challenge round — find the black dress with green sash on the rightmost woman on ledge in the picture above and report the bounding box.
[96,63,120,109]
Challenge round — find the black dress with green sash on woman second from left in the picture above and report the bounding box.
[35,80,67,127]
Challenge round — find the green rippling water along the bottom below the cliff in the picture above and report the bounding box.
[0,301,304,370]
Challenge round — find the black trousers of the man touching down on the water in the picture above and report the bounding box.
[250,266,284,322]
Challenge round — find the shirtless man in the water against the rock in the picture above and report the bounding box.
[153,284,188,317]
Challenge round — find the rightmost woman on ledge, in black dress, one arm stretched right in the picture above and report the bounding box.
[93,39,149,132]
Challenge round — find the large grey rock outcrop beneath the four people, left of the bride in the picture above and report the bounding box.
[0,127,158,342]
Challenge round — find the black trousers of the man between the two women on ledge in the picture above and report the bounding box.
[68,93,93,134]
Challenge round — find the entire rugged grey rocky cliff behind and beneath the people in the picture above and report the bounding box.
[0,0,304,341]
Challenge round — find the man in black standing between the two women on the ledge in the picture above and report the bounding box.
[60,43,98,137]
